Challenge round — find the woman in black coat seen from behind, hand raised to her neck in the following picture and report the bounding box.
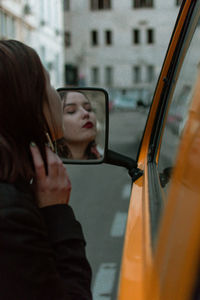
[0,40,92,300]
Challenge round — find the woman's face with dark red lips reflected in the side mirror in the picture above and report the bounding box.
[63,92,97,143]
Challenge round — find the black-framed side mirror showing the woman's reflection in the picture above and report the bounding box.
[56,88,108,163]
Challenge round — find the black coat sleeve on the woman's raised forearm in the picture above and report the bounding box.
[42,205,92,299]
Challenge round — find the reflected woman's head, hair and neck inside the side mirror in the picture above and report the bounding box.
[58,90,100,160]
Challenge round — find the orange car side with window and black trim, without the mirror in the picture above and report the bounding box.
[118,0,200,300]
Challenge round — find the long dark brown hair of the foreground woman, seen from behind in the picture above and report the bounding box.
[0,40,50,183]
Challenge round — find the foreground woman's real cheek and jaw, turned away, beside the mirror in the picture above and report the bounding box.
[44,69,63,140]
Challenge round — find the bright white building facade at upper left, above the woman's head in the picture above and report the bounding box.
[0,0,64,87]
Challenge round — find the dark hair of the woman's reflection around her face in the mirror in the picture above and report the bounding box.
[57,90,99,159]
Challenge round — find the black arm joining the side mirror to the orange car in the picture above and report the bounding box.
[104,149,143,182]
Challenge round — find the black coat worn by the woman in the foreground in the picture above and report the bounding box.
[0,183,92,300]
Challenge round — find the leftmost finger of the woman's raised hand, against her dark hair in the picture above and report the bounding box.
[30,143,46,179]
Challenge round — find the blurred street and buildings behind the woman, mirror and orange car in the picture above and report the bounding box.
[0,0,181,300]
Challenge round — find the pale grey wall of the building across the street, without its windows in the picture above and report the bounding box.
[64,0,179,98]
